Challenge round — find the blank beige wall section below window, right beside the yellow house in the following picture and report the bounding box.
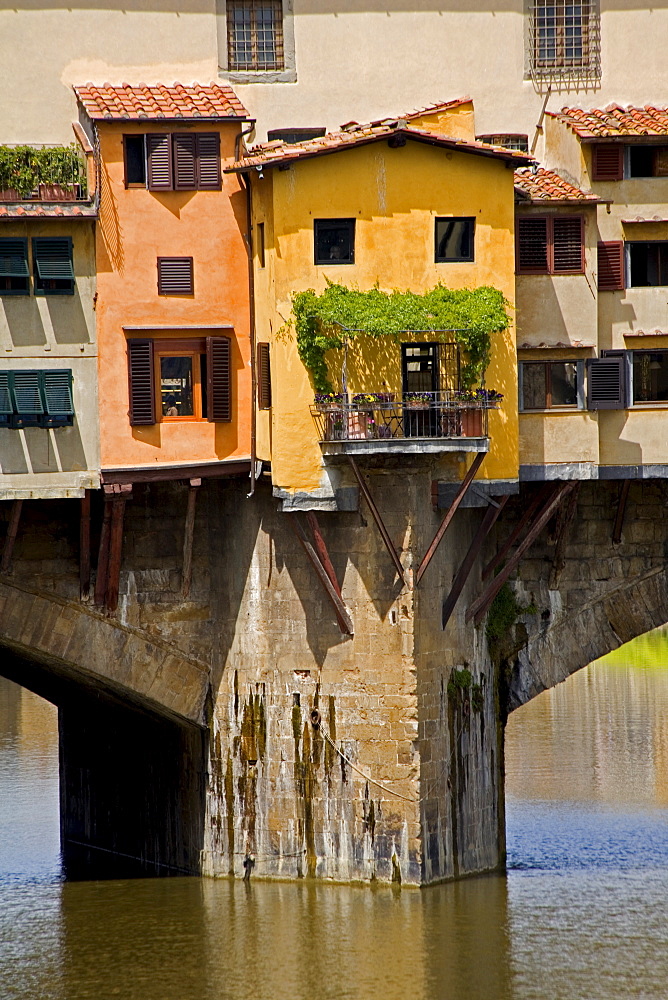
[520,410,599,465]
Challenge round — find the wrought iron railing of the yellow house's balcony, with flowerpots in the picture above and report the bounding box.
[311,392,495,442]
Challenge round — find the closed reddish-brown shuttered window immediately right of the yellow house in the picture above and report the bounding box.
[517,215,584,274]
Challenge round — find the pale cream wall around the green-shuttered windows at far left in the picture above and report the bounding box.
[0,220,100,499]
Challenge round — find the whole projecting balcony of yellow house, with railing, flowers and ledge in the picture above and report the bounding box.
[311,390,496,456]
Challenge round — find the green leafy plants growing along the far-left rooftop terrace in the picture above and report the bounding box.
[0,143,86,198]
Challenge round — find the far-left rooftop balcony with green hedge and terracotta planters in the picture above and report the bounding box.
[0,140,95,207]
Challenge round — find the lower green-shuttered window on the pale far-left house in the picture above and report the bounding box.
[0,368,74,428]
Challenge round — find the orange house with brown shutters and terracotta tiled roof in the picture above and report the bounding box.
[75,84,252,486]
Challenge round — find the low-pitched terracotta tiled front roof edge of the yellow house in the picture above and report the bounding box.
[227,118,532,172]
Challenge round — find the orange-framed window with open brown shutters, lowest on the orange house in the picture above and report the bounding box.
[127,337,232,426]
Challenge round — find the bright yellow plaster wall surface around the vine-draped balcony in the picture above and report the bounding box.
[253,141,518,498]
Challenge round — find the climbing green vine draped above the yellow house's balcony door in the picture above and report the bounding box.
[292,283,510,392]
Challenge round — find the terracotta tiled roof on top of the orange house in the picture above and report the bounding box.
[74,83,248,121]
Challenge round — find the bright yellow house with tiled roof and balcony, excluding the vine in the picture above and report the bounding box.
[233,99,528,509]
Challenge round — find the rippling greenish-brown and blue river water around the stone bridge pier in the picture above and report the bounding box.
[0,635,668,1000]
